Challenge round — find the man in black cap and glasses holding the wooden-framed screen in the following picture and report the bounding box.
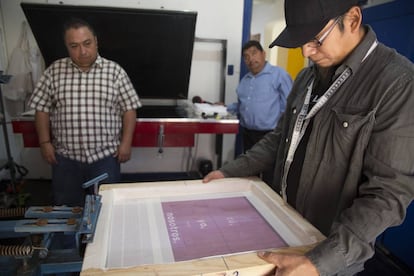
[203,0,414,276]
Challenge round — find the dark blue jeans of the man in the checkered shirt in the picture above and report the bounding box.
[52,154,121,207]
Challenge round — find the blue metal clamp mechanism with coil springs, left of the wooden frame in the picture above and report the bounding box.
[0,173,108,276]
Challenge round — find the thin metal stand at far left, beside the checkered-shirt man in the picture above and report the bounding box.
[0,71,27,193]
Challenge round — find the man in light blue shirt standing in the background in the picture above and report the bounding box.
[227,40,292,183]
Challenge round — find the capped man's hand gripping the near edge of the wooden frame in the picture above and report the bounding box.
[257,252,319,276]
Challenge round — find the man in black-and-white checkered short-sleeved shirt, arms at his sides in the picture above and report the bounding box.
[29,18,141,206]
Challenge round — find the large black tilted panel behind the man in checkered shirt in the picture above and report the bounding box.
[21,3,197,99]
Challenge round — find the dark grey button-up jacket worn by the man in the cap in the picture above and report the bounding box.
[220,26,414,275]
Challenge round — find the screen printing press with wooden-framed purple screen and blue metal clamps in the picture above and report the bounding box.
[0,176,324,276]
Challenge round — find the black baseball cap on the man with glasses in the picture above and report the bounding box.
[269,0,360,48]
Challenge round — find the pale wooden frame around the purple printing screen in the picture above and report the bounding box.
[81,178,324,276]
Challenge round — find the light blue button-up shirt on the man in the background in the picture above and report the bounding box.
[227,62,292,130]
